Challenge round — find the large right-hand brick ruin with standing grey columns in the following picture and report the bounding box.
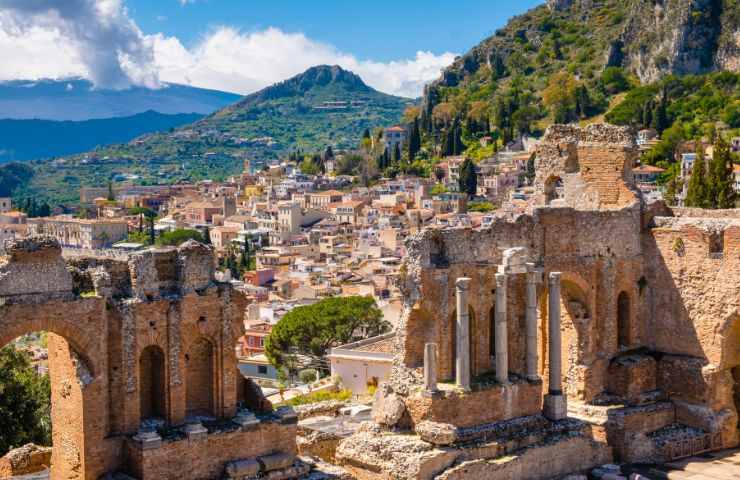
[336,125,740,480]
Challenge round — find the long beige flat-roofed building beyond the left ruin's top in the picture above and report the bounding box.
[28,216,128,248]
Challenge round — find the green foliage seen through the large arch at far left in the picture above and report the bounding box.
[0,345,51,456]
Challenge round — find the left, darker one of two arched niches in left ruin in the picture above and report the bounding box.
[139,345,167,421]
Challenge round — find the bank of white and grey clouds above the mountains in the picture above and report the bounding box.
[0,0,455,97]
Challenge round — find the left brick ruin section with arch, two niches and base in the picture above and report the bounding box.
[0,238,308,480]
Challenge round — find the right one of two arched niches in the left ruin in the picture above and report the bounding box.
[185,337,214,418]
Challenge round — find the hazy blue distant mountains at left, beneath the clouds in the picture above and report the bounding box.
[0,79,241,164]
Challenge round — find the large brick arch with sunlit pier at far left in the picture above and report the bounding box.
[0,299,104,478]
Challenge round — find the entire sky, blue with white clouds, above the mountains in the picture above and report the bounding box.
[0,0,542,97]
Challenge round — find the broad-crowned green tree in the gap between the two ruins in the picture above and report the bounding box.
[265,296,390,374]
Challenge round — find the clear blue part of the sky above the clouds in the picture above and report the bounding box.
[127,0,543,62]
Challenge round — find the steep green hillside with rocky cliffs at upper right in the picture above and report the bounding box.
[388,0,740,190]
